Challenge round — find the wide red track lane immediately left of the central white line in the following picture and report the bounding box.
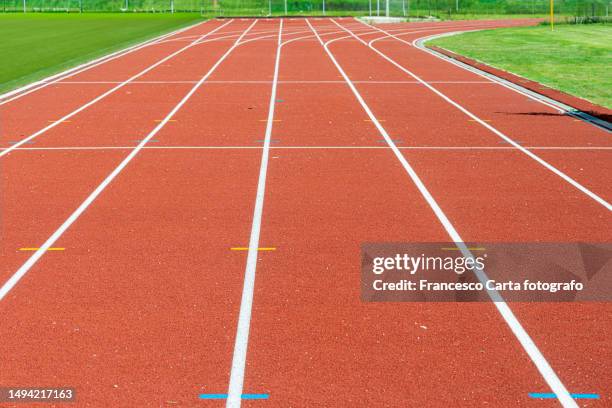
[0,17,270,406]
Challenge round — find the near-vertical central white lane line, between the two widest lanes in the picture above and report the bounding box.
[226,19,283,408]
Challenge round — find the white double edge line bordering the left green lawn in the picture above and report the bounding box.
[0,20,211,106]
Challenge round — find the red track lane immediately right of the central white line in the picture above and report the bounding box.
[238,17,572,406]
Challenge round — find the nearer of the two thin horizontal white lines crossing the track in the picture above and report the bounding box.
[9,145,612,151]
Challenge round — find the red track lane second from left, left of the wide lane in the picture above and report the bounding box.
[0,24,260,282]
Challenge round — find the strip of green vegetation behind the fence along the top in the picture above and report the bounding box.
[0,0,610,19]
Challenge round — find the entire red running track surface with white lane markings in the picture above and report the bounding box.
[0,18,612,407]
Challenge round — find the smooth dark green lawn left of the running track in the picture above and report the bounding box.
[0,13,206,93]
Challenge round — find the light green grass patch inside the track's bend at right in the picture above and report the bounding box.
[429,24,612,108]
